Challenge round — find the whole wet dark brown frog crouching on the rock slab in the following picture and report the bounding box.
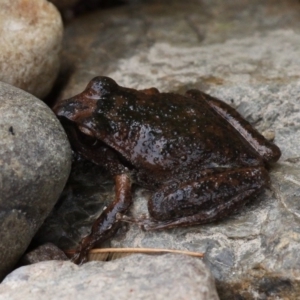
[54,77,281,263]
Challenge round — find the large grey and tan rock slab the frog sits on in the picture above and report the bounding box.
[28,0,300,299]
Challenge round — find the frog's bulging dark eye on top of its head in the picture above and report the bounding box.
[86,76,118,99]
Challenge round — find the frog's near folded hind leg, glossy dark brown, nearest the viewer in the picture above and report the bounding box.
[144,167,269,230]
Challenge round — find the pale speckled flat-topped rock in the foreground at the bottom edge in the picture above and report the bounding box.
[0,254,219,300]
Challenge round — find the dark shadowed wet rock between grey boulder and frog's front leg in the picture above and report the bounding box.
[35,158,114,250]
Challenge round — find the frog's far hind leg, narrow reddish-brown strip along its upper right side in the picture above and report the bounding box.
[186,90,281,163]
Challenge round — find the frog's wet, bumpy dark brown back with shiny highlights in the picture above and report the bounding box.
[85,88,258,178]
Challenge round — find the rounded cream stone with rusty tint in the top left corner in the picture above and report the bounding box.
[0,0,63,98]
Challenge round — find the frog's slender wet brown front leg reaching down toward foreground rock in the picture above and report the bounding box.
[72,174,132,264]
